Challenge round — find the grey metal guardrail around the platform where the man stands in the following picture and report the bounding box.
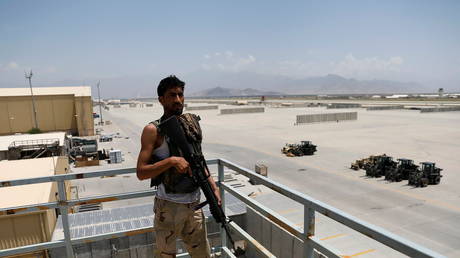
[0,159,443,257]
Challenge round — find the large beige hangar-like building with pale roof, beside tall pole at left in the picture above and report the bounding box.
[0,86,94,136]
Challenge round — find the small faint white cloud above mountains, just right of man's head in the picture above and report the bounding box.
[201,50,257,72]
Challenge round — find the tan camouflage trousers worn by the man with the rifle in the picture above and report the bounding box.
[154,198,211,258]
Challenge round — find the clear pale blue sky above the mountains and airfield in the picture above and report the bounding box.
[0,0,460,97]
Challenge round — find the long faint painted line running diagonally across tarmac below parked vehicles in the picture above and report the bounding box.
[210,142,460,211]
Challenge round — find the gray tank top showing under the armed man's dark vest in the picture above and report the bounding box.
[153,137,201,203]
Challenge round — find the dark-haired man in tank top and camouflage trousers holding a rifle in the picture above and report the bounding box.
[137,75,220,258]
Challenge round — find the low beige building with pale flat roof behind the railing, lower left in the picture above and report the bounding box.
[0,156,70,257]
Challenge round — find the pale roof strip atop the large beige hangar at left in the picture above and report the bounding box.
[0,86,91,97]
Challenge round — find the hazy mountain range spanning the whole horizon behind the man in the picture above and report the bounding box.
[0,70,436,98]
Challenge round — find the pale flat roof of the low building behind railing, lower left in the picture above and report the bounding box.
[0,157,58,208]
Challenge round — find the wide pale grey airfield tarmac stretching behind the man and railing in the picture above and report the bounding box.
[77,101,460,257]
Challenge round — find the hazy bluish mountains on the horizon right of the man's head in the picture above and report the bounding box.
[189,73,432,97]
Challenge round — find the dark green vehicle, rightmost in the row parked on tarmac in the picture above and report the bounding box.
[408,162,442,187]
